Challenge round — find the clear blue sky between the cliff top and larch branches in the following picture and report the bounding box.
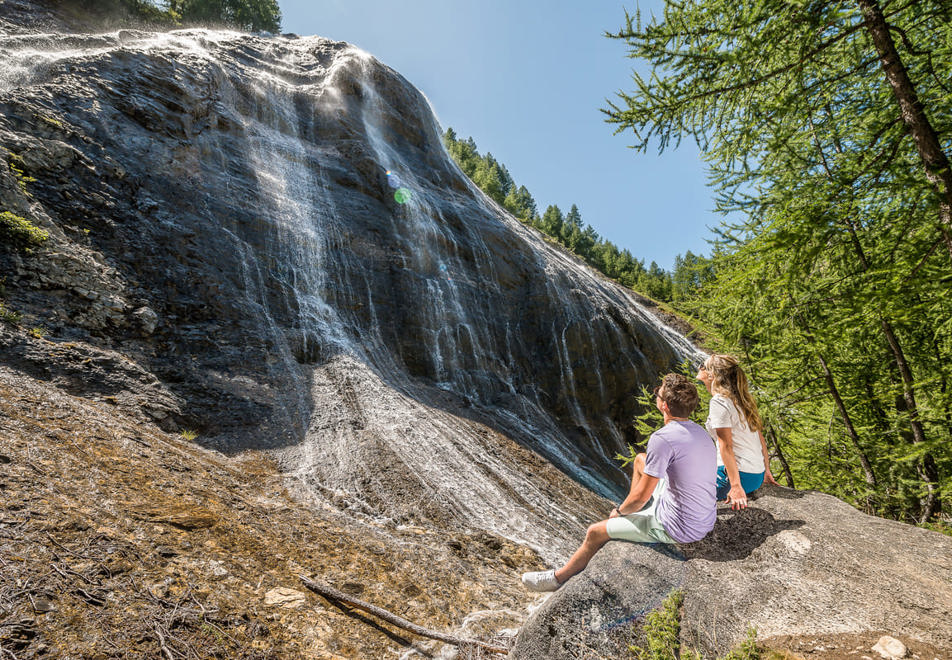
[279,0,720,269]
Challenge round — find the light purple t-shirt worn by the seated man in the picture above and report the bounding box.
[645,420,717,543]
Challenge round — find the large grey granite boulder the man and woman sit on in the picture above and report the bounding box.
[511,487,952,660]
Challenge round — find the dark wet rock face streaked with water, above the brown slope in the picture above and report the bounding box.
[0,15,692,548]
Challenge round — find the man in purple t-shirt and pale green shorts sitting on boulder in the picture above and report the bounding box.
[522,374,717,591]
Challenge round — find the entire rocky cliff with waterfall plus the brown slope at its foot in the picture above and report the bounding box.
[0,0,693,658]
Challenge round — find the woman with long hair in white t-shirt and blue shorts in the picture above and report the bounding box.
[697,355,777,510]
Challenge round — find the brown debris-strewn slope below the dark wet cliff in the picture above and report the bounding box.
[0,348,541,659]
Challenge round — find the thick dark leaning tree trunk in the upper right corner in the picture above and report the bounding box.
[856,0,952,259]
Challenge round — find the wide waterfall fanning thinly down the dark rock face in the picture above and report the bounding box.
[0,30,696,556]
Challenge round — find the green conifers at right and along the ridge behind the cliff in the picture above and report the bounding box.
[445,0,952,526]
